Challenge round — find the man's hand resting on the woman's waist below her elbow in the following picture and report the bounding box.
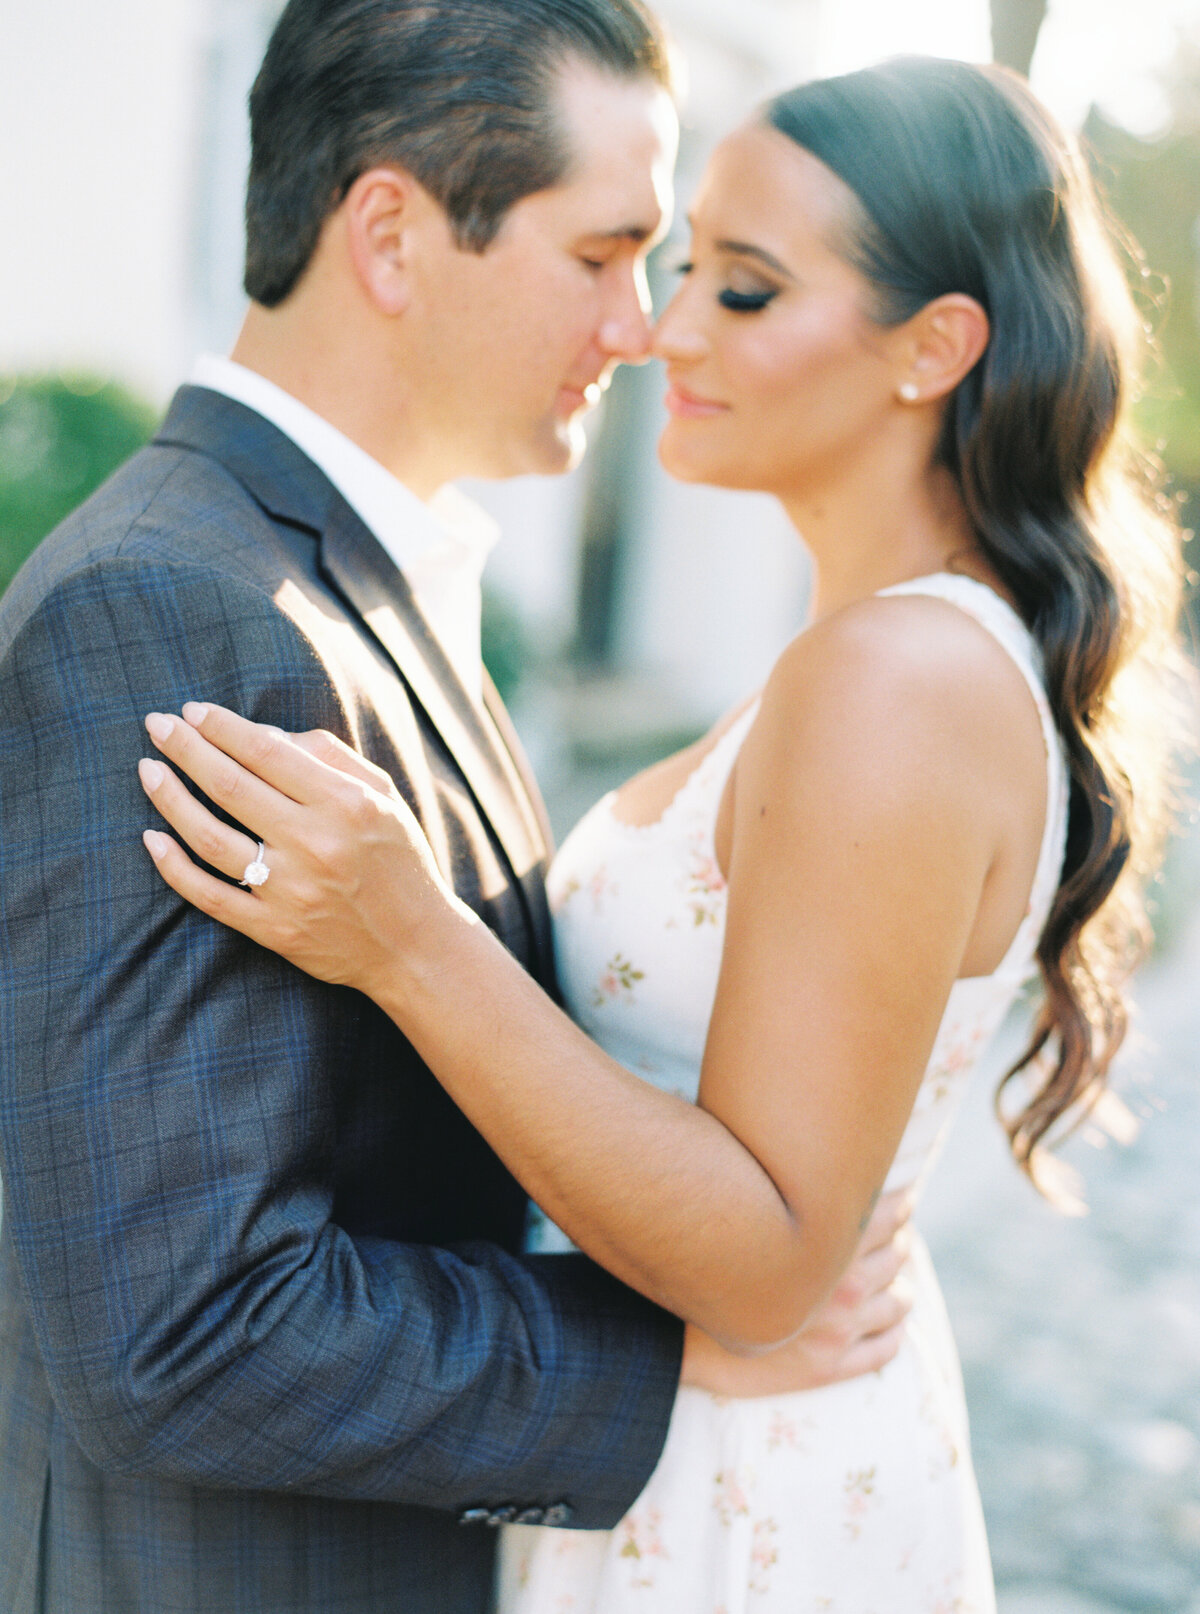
[680,1188,913,1398]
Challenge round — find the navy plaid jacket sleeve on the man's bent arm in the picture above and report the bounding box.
[0,558,680,1527]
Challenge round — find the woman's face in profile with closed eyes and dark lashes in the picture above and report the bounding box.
[654,124,901,502]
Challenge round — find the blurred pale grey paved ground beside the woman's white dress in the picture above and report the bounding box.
[922,890,1200,1614]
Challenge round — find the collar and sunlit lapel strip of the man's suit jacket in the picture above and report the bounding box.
[155,386,549,957]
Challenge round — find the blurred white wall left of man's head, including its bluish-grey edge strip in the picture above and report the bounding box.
[0,0,275,404]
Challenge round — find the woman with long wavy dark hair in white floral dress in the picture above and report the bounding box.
[138,60,1179,1614]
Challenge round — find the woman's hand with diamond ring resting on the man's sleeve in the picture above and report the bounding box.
[139,704,468,994]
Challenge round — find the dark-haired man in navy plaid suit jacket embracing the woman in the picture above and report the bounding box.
[0,0,904,1614]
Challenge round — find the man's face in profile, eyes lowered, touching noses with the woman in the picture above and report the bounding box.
[405,63,678,479]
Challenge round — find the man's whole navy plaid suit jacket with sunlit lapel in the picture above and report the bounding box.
[0,387,680,1614]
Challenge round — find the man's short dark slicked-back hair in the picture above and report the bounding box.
[245,0,670,308]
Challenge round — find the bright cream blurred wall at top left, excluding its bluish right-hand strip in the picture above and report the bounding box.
[0,0,200,397]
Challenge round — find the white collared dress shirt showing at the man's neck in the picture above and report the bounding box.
[189,353,497,700]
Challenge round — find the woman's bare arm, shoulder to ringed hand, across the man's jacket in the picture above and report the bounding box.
[138,600,1027,1351]
